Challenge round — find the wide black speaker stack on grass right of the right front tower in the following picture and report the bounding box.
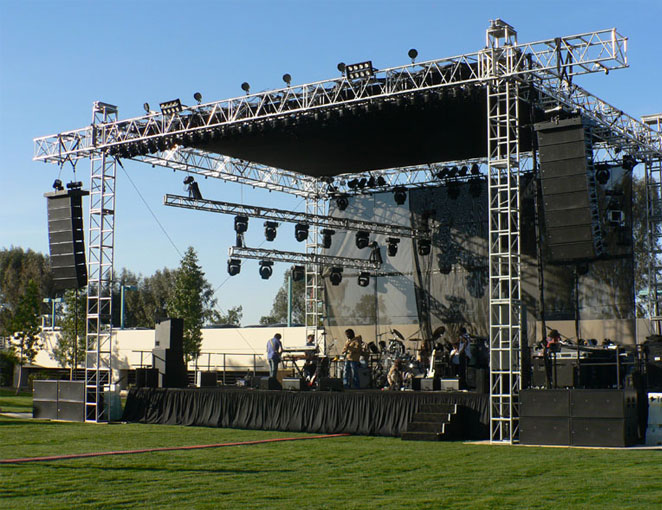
[520,390,638,446]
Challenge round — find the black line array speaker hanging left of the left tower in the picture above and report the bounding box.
[44,188,89,290]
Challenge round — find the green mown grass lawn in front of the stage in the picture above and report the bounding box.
[0,392,662,510]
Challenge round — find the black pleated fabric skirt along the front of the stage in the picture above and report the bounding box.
[122,388,489,439]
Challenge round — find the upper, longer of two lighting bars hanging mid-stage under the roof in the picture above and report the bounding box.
[163,194,430,239]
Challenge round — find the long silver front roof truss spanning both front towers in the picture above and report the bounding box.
[34,29,627,163]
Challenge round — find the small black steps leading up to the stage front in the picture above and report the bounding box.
[402,404,461,441]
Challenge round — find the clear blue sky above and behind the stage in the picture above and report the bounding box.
[0,0,662,324]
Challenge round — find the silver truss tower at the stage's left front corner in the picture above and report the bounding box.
[85,102,117,422]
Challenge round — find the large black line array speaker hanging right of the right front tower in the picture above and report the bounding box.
[535,117,603,263]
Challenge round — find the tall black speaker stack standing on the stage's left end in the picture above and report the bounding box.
[152,319,188,388]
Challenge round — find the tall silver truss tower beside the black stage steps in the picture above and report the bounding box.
[480,20,526,443]
